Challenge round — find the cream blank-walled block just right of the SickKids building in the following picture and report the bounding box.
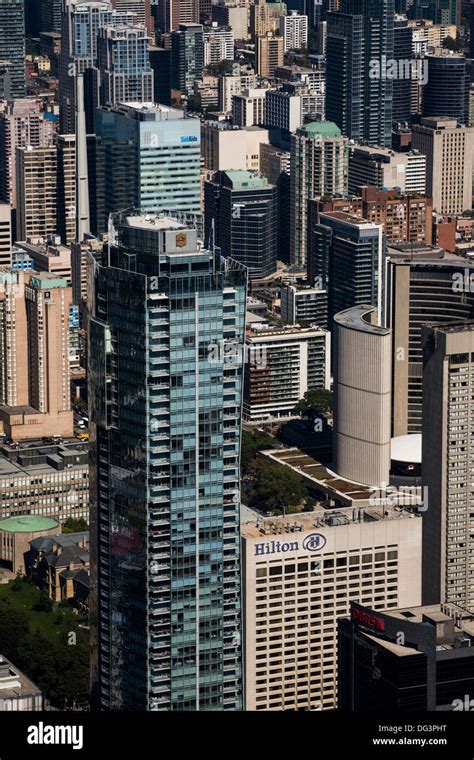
[201,121,269,172]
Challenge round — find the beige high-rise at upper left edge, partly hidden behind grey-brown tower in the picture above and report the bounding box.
[0,98,53,209]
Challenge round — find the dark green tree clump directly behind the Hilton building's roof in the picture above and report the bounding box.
[248,459,307,514]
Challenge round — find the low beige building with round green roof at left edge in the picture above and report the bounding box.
[0,515,59,575]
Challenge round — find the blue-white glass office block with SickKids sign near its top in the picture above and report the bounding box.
[95,103,201,233]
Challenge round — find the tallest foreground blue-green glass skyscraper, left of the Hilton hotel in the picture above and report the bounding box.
[89,212,246,710]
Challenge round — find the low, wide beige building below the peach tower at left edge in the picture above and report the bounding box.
[0,440,89,532]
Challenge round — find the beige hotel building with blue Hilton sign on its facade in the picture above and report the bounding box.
[241,505,422,710]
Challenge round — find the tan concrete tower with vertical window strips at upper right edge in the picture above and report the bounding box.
[412,116,474,214]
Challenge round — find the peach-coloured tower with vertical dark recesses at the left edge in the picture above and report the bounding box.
[0,268,73,441]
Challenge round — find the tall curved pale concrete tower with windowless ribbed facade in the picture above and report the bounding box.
[334,306,392,487]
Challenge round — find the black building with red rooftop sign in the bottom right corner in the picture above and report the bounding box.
[338,604,474,715]
